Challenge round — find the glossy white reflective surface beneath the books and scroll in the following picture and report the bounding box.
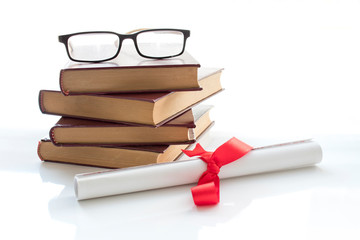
[0,130,360,239]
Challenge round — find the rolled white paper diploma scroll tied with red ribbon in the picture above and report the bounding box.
[75,140,322,200]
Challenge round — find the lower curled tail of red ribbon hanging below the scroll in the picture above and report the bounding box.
[191,176,220,206]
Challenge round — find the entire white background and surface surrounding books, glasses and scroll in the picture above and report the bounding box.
[0,0,360,240]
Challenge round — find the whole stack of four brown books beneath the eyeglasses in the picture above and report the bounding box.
[38,47,222,168]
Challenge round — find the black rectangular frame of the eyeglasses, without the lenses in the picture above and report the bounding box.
[59,28,190,63]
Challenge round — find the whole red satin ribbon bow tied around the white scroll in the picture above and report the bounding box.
[182,137,253,206]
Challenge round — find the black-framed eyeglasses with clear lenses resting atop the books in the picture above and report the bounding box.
[59,29,190,62]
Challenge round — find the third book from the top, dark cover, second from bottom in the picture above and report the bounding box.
[49,104,211,146]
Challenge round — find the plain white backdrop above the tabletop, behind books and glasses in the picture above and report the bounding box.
[0,0,360,136]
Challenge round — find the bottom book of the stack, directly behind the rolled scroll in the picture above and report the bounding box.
[38,105,212,168]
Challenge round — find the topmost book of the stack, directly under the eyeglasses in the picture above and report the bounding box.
[60,49,201,95]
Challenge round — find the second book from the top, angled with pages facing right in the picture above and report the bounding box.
[39,68,222,126]
